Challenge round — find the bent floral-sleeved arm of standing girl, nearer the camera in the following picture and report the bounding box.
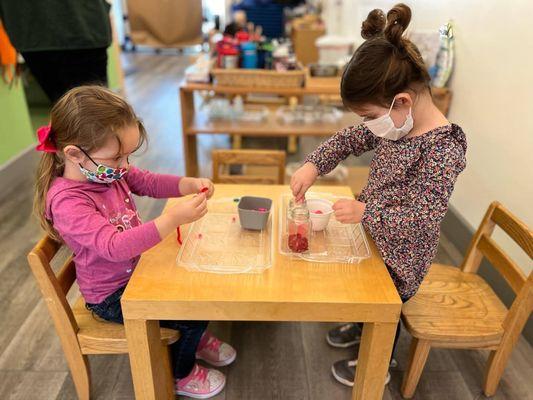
[362,138,466,240]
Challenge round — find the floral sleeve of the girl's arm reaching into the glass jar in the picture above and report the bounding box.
[305,124,380,175]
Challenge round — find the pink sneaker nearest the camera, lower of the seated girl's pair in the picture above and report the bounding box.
[176,364,226,399]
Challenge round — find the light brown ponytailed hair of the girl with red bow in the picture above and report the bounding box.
[33,86,146,241]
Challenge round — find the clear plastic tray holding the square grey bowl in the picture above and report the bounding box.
[176,198,274,274]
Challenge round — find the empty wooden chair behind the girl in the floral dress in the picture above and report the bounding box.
[402,202,533,398]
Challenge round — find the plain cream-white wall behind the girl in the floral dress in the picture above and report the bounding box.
[340,0,533,273]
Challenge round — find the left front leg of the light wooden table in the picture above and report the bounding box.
[124,319,172,400]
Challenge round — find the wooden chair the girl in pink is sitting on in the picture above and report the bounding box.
[28,237,179,400]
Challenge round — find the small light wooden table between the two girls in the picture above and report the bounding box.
[122,185,402,400]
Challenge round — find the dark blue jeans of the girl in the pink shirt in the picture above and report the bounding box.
[86,287,208,379]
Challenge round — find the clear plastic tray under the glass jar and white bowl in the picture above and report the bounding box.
[278,193,371,264]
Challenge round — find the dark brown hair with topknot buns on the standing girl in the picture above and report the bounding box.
[341,3,430,107]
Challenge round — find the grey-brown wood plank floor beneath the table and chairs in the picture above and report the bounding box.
[0,54,533,400]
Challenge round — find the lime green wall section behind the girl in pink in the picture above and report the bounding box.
[0,79,35,167]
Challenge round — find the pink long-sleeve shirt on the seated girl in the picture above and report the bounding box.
[46,166,181,304]
